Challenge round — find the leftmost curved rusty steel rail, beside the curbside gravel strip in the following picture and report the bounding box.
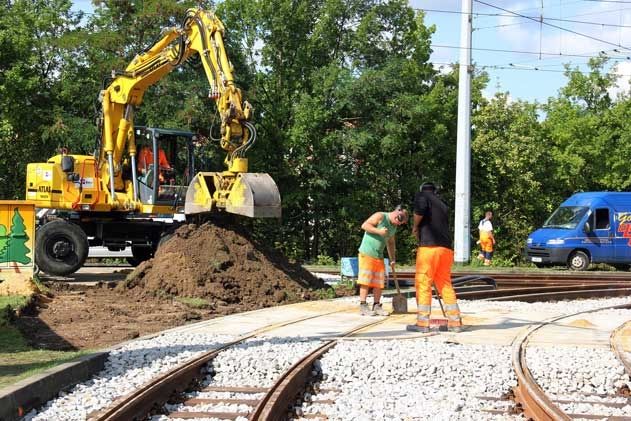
[87,310,344,421]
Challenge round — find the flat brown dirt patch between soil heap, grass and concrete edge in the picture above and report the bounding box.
[14,282,222,350]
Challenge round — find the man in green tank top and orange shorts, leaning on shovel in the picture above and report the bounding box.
[357,206,408,316]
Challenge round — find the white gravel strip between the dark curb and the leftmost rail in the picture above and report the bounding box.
[25,332,236,421]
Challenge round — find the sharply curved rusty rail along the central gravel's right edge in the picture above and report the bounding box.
[512,304,631,421]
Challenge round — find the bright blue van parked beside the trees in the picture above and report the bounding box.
[525,192,631,270]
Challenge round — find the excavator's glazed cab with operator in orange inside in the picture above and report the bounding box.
[135,127,195,211]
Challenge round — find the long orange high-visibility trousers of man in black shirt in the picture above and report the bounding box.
[414,247,462,327]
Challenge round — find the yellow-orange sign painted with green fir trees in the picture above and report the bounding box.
[0,200,35,285]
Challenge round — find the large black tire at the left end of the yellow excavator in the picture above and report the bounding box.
[35,219,90,276]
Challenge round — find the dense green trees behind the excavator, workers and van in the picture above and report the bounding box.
[0,0,631,263]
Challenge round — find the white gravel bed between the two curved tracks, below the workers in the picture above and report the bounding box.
[296,339,523,421]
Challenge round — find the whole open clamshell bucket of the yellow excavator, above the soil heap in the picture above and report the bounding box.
[184,172,281,218]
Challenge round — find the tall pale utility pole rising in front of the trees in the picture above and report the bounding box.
[454,0,473,263]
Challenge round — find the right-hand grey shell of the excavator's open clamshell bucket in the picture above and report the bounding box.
[226,173,281,218]
